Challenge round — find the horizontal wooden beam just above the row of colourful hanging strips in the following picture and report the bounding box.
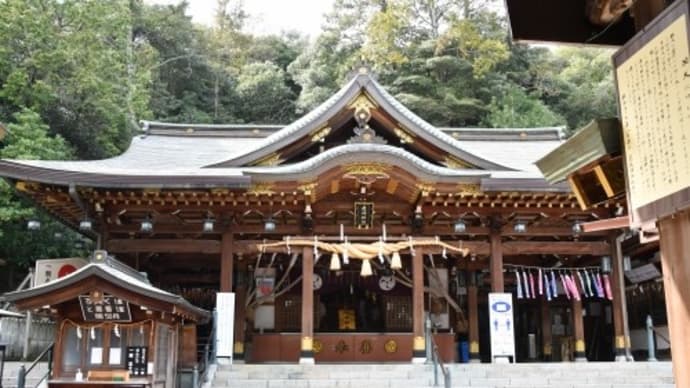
[503,241,611,256]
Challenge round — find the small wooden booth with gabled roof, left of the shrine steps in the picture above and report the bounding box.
[4,251,209,388]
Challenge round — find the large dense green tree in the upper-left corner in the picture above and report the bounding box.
[0,0,151,158]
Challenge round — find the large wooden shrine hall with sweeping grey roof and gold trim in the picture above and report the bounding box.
[0,69,623,362]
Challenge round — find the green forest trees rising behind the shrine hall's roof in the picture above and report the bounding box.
[0,0,616,278]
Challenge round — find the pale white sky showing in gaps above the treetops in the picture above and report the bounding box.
[145,0,333,37]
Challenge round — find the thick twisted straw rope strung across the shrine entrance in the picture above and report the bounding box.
[257,237,469,260]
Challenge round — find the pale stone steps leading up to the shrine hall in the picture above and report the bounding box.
[212,362,680,388]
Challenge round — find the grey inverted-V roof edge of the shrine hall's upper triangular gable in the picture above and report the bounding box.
[207,73,514,170]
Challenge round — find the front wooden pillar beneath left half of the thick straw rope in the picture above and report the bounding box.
[299,247,314,364]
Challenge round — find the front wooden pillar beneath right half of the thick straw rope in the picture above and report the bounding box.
[412,247,426,362]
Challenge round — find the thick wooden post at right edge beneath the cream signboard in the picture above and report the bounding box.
[659,211,690,387]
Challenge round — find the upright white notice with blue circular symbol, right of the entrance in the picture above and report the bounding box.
[489,292,515,362]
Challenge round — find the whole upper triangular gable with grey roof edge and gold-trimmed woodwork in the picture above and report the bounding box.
[207,70,512,170]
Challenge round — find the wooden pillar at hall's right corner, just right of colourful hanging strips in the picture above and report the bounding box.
[609,236,630,361]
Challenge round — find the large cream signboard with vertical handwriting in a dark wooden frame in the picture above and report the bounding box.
[613,0,690,226]
